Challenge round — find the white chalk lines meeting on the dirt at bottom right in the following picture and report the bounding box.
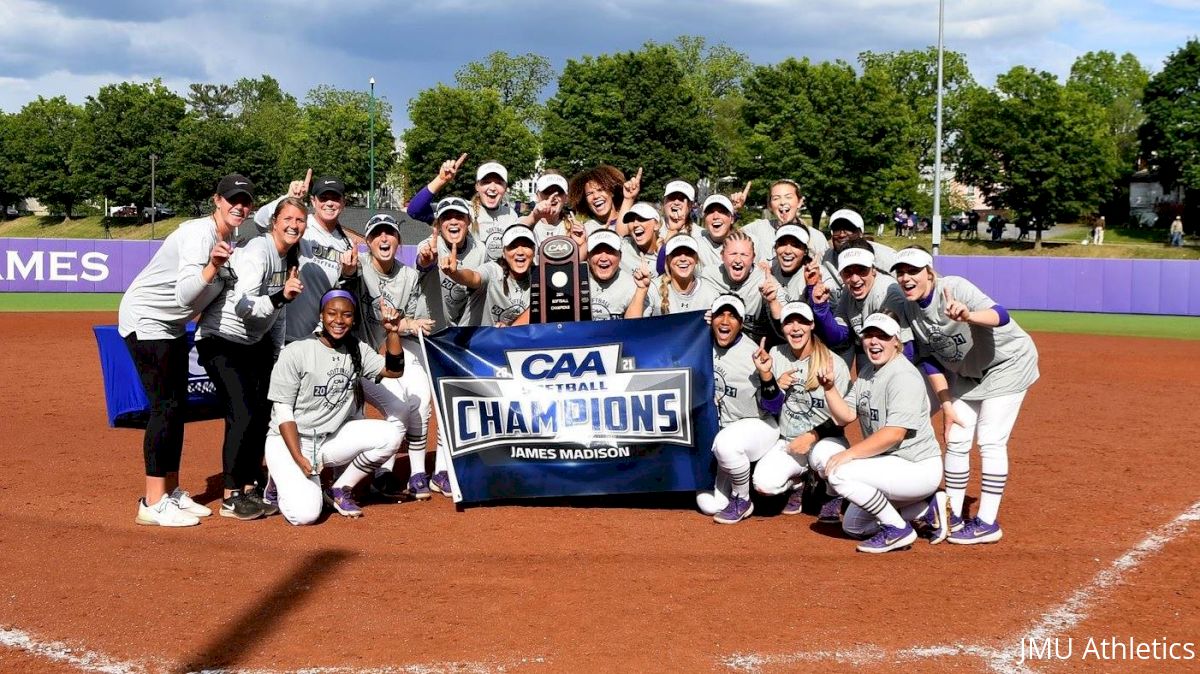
[718,501,1200,674]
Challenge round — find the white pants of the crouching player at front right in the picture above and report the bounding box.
[809,444,942,536]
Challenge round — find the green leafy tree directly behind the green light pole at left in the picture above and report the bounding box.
[282,85,396,192]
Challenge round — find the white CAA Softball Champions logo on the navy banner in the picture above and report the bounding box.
[438,344,692,456]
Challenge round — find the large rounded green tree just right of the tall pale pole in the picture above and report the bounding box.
[955,66,1117,247]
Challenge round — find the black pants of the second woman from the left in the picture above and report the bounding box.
[196,336,275,489]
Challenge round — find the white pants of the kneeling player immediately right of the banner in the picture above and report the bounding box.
[696,417,779,514]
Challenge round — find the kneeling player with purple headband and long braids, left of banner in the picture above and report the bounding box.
[266,285,404,524]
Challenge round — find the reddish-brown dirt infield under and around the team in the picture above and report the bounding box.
[0,314,1200,674]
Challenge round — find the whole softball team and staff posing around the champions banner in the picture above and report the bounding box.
[119,155,1038,553]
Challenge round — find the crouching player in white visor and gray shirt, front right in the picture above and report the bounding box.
[809,313,949,553]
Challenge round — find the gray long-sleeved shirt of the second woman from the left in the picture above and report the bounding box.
[196,234,288,349]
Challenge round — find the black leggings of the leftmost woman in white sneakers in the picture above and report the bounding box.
[125,332,190,477]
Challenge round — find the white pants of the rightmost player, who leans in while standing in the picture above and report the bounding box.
[946,391,1025,523]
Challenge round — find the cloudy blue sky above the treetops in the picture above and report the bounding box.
[0,0,1200,128]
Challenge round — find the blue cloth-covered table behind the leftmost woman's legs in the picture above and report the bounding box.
[92,323,224,428]
